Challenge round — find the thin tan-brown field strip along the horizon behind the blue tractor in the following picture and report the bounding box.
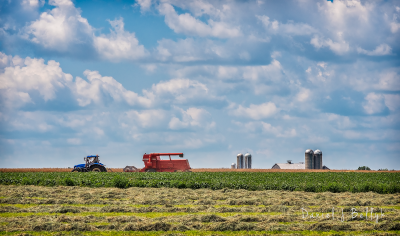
[0,168,400,173]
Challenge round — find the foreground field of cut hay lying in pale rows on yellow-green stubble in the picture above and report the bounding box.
[0,185,400,235]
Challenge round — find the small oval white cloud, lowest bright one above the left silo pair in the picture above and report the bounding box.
[230,102,279,120]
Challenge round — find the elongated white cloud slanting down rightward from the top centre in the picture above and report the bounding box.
[159,3,241,38]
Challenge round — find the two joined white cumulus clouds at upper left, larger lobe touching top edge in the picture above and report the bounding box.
[22,0,148,61]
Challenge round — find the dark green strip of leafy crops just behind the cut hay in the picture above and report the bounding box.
[0,172,400,194]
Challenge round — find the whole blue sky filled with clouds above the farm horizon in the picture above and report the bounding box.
[0,0,400,170]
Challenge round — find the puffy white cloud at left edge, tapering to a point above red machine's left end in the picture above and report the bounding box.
[0,55,151,108]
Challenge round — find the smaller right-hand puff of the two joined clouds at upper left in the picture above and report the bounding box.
[94,18,147,61]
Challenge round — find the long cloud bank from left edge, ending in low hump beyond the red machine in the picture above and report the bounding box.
[0,54,226,108]
